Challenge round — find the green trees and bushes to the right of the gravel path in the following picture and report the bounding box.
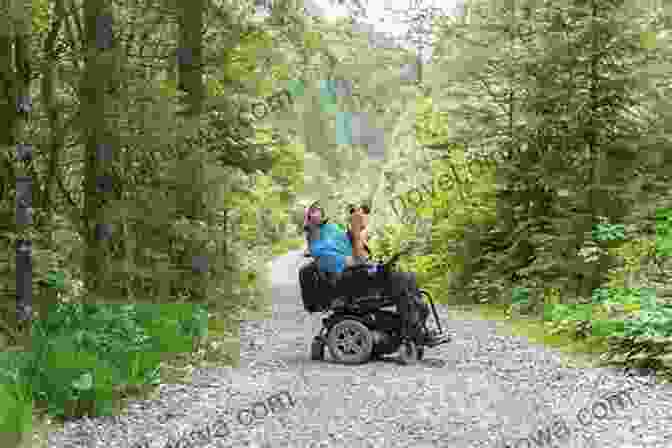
[370,1,672,382]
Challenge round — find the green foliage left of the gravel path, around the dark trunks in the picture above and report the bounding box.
[0,0,372,442]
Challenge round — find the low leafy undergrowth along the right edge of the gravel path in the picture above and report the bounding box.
[443,214,672,381]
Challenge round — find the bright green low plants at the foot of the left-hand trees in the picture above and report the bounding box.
[0,302,208,417]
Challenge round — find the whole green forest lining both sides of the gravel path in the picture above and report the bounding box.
[0,0,672,446]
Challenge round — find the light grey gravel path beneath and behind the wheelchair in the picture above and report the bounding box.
[49,251,672,448]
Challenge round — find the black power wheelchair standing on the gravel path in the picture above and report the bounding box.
[299,250,448,365]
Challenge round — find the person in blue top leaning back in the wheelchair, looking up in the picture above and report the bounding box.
[305,203,445,346]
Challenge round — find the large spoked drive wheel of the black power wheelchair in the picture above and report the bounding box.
[327,319,373,364]
